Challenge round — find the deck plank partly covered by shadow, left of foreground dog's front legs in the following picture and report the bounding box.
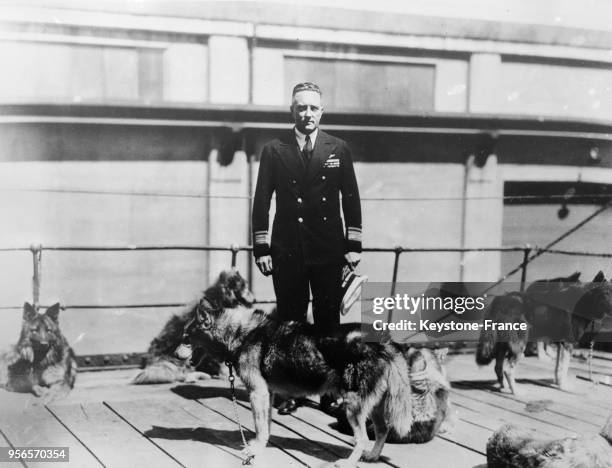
[105,398,240,467]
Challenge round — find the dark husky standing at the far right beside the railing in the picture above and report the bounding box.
[476,271,612,394]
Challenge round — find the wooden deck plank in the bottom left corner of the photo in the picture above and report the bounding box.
[0,405,102,467]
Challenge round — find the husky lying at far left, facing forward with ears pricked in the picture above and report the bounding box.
[0,302,77,400]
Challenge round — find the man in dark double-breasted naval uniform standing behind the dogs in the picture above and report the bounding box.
[252,83,361,412]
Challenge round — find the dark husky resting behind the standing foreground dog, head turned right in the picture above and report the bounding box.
[132,269,255,384]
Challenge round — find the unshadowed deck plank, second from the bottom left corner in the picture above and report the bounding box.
[49,403,179,468]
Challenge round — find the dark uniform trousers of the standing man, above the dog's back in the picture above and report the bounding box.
[272,256,343,332]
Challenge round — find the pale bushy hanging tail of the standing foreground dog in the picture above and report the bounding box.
[385,353,413,437]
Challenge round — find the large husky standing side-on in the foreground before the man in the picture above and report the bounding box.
[185,298,413,466]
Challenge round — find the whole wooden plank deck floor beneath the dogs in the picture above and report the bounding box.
[0,354,612,468]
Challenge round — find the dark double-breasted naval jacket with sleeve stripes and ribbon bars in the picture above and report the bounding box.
[252,130,361,266]
